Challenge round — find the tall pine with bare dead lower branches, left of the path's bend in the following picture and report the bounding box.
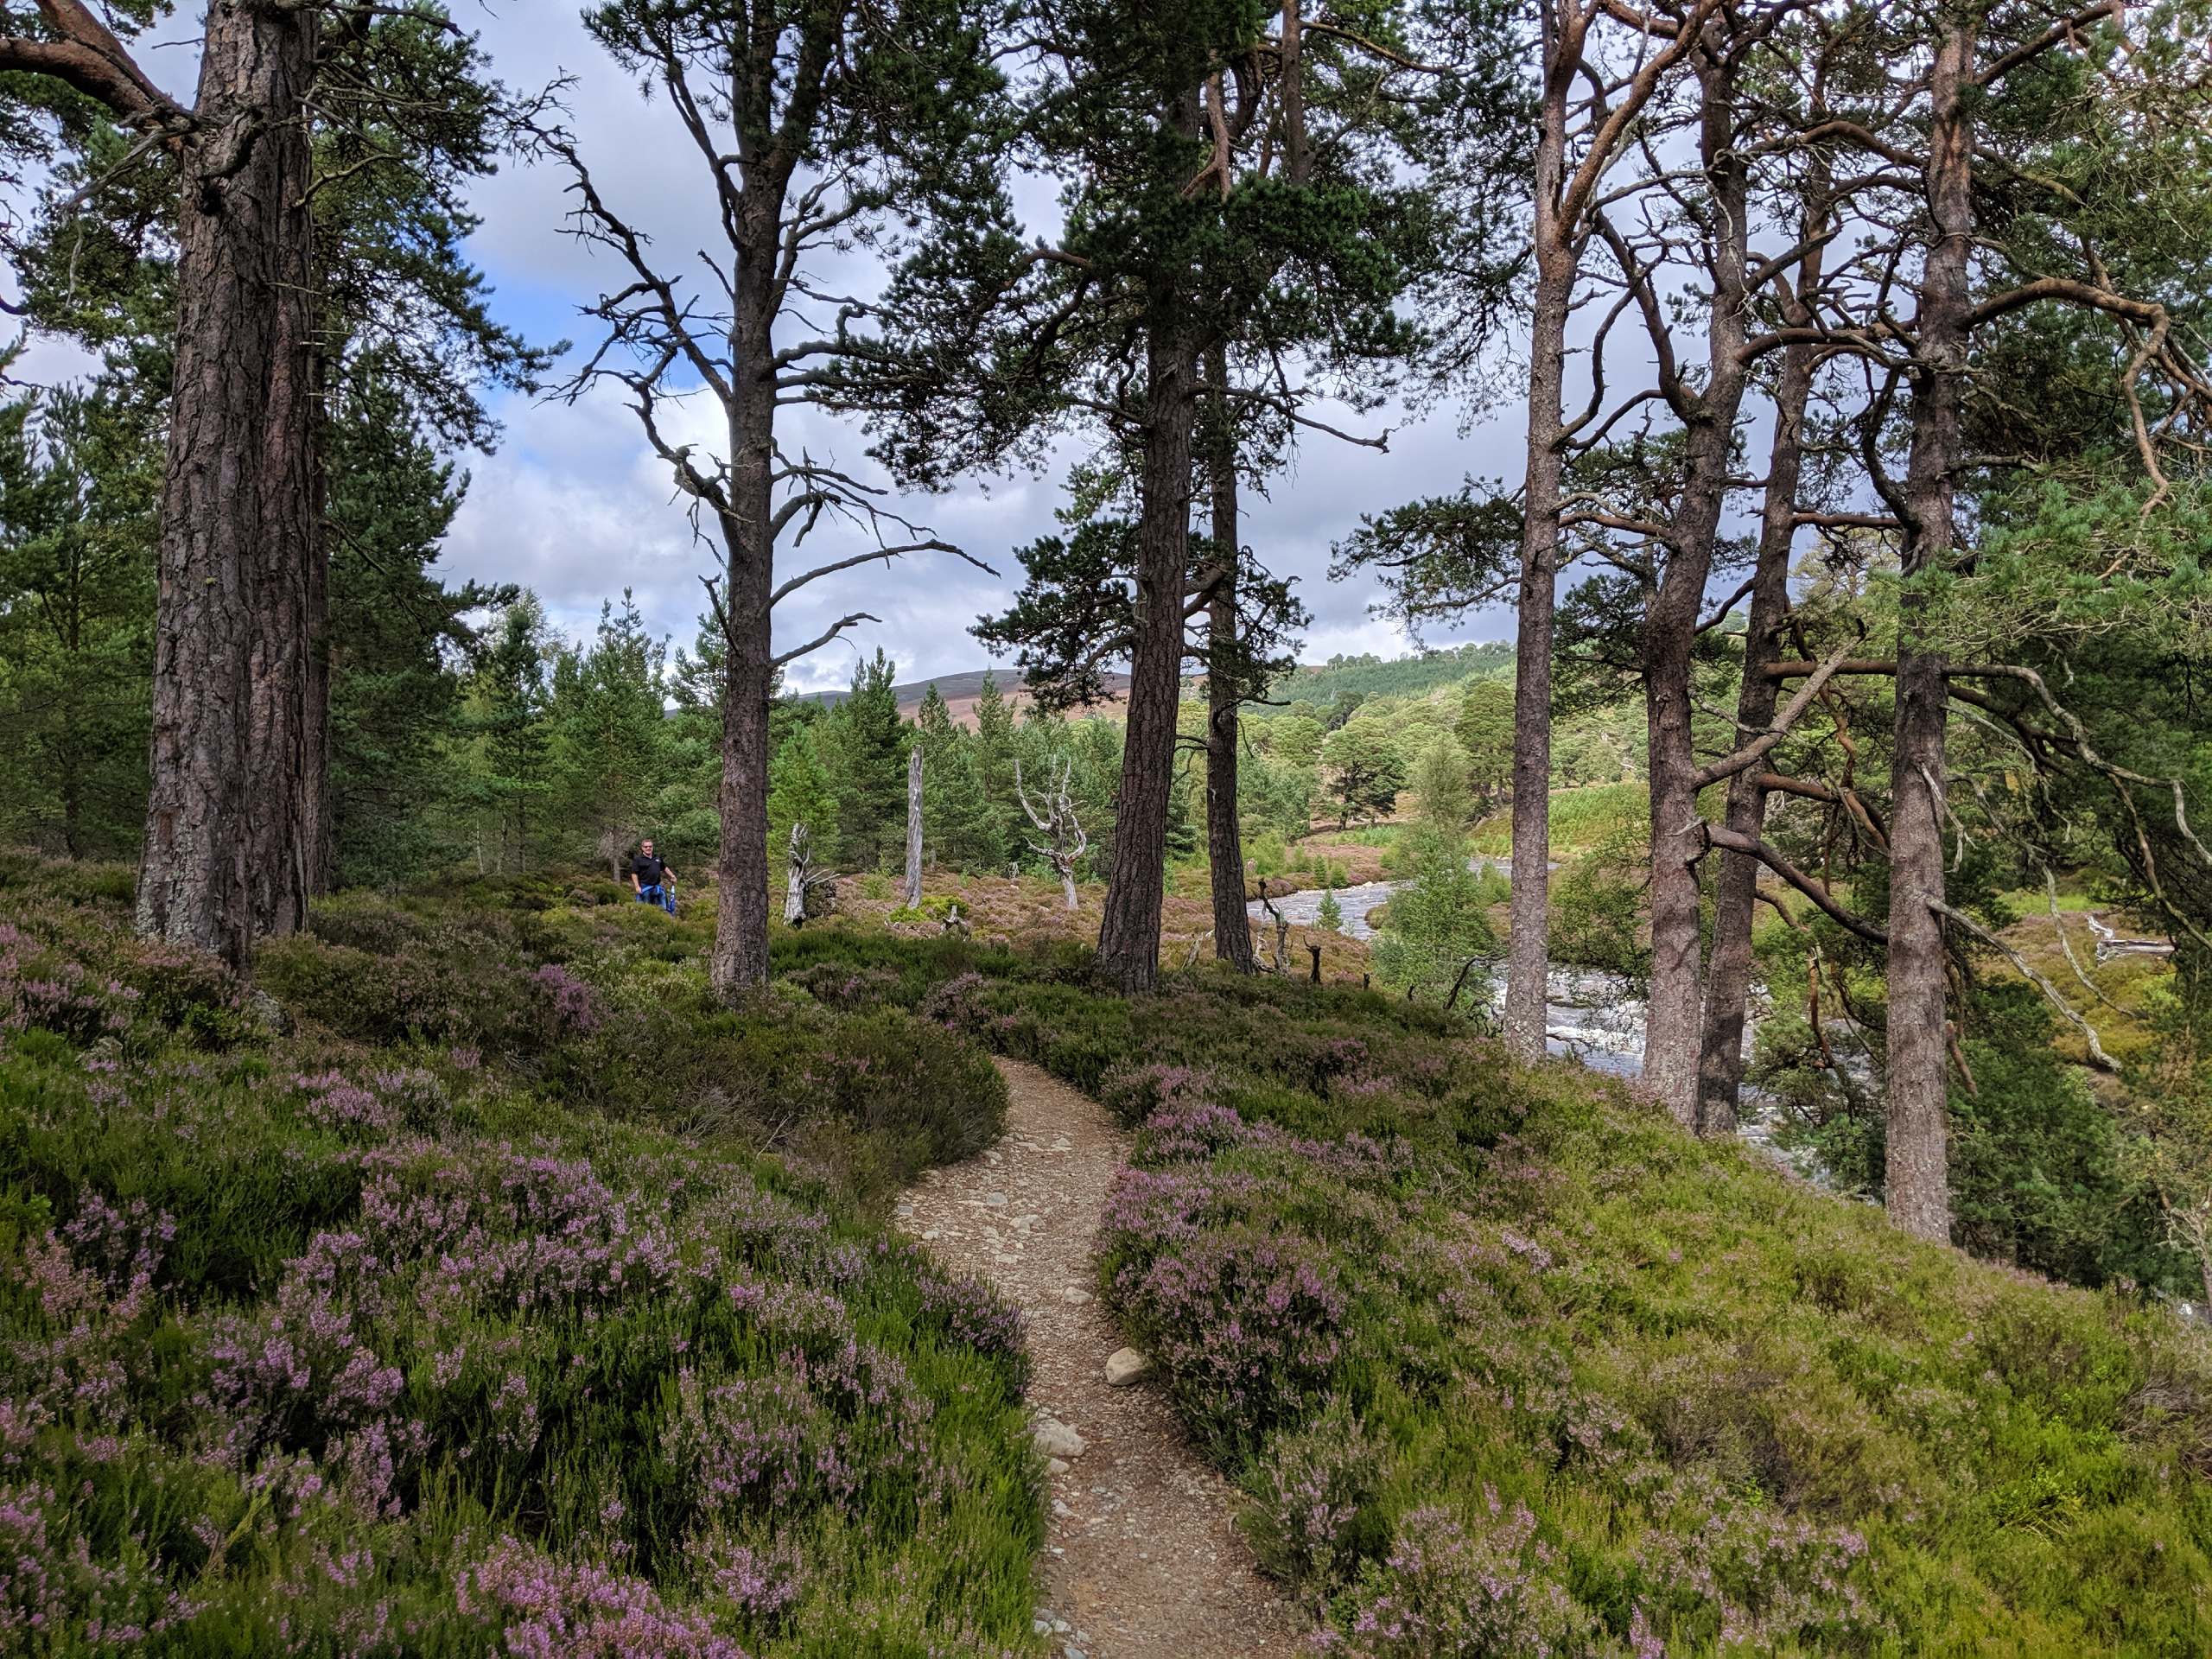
[540,0,991,1000]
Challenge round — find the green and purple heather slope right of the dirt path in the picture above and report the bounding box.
[787,933,2212,1659]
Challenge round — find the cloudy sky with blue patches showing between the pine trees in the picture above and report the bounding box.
[22,0,1522,688]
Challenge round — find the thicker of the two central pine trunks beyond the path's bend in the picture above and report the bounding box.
[1099,305,1197,991]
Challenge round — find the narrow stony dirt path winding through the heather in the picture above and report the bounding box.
[898,1059,1300,1659]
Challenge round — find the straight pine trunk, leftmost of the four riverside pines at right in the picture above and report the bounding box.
[1504,39,1575,1062]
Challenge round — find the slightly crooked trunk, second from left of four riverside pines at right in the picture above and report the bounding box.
[1643,41,1747,1128]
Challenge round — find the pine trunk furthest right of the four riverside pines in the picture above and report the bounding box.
[1887,13,1978,1239]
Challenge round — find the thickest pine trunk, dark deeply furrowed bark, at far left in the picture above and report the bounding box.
[137,7,319,969]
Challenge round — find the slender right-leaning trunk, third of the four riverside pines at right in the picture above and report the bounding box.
[1697,163,1829,1135]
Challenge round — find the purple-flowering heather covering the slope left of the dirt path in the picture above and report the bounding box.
[0,875,1039,1659]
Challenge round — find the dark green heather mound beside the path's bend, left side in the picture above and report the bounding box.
[259,887,1007,1201]
